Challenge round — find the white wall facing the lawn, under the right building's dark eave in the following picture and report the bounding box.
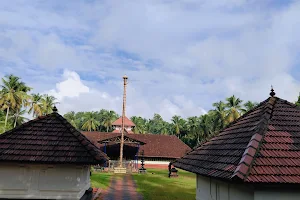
[196,175,254,200]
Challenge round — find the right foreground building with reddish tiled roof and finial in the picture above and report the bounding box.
[173,89,300,200]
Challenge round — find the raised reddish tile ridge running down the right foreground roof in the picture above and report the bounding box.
[231,97,277,180]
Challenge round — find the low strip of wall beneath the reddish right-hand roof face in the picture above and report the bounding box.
[254,189,300,200]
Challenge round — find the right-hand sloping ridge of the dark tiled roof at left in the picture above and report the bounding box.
[53,113,109,161]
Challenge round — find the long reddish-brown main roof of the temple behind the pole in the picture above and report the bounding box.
[83,132,191,158]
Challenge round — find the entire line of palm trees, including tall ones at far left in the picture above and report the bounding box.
[0,75,300,147]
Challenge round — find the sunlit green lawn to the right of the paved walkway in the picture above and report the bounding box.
[133,169,196,200]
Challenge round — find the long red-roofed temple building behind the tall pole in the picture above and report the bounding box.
[82,117,191,169]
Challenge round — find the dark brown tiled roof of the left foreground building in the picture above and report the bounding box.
[0,113,107,164]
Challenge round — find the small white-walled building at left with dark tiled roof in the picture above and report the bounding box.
[0,109,107,200]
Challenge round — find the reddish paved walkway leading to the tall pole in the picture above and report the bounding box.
[100,174,143,200]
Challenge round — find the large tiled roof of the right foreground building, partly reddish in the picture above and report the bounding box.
[174,97,300,183]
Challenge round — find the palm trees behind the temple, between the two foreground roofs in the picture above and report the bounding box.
[64,95,257,147]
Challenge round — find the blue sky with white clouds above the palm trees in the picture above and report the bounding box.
[0,0,300,120]
